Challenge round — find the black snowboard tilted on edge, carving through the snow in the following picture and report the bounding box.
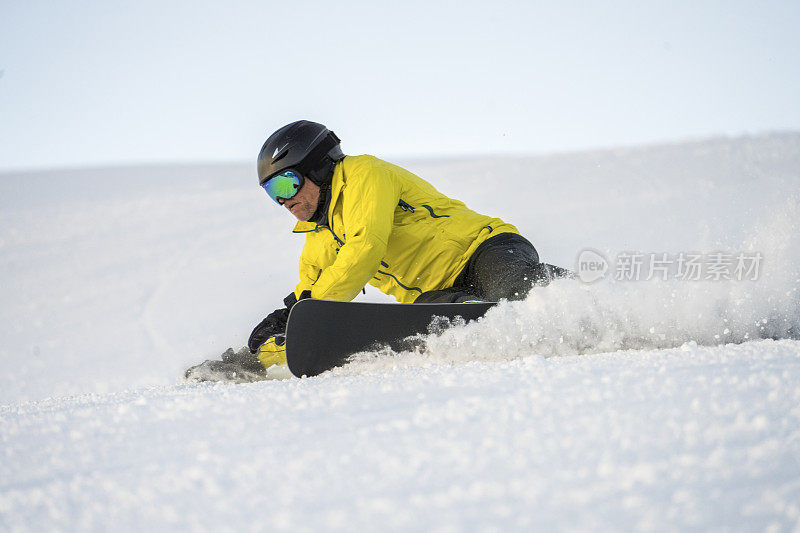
[286,299,496,377]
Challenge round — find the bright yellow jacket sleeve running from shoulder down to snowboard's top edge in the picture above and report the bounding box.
[311,159,400,301]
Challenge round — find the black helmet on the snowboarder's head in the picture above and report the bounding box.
[258,120,344,185]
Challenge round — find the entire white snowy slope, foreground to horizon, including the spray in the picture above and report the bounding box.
[0,134,800,531]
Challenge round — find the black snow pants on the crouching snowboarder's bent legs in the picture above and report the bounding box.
[414,233,573,303]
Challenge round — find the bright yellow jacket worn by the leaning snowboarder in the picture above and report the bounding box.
[294,155,519,303]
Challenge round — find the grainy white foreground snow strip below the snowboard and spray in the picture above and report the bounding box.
[0,340,800,531]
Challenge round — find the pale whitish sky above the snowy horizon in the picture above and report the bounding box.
[0,0,800,171]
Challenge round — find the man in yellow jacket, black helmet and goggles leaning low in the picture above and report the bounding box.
[187,120,570,379]
